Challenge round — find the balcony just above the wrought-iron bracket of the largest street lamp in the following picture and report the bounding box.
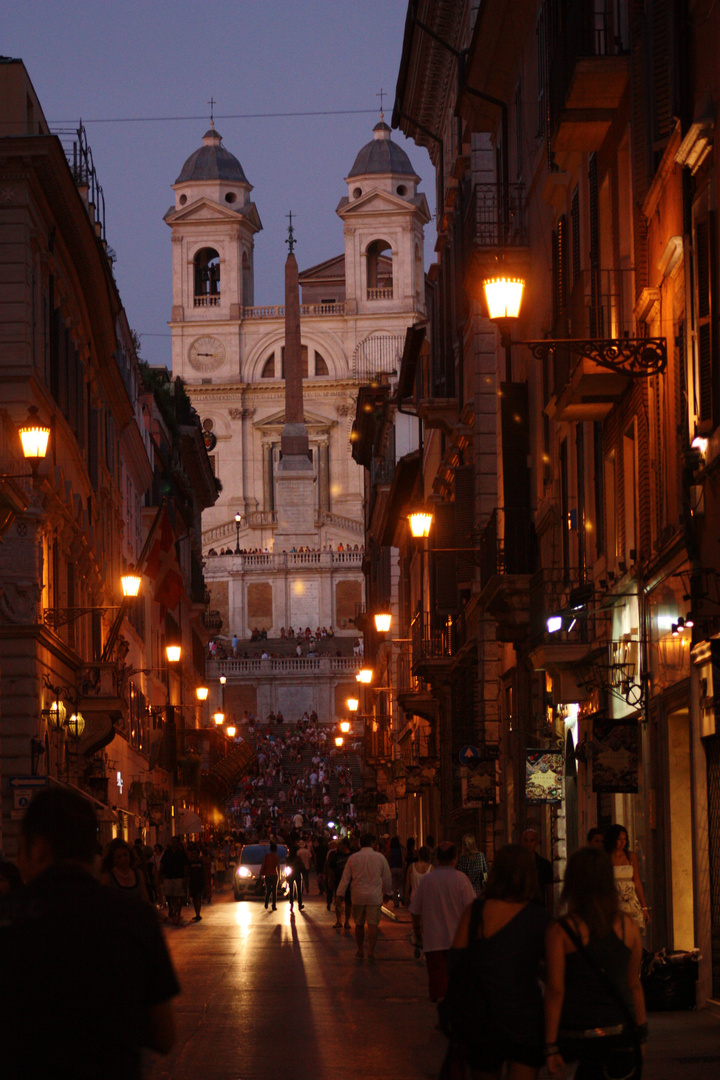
[552,270,631,421]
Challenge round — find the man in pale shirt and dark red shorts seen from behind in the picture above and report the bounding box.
[410,840,475,1001]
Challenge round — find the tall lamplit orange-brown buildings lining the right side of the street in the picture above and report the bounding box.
[349,0,720,1000]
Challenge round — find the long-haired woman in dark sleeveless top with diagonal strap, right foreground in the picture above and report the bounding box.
[545,847,648,1080]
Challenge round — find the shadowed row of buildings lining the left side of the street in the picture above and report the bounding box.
[0,59,217,858]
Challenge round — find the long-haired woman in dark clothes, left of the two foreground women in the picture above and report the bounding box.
[454,843,549,1080]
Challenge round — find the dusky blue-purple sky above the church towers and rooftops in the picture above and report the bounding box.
[0,0,435,364]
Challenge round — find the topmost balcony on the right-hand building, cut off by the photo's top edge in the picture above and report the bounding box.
[548,0,629,158]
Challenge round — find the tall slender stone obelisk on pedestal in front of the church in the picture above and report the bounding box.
[274,215,317,551]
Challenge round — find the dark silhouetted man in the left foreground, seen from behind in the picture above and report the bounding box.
[0,787,179,1080]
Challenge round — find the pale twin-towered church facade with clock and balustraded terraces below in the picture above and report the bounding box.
[165,120,430,716]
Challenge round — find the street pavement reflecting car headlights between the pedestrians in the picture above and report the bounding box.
[147,882,720,1080]
